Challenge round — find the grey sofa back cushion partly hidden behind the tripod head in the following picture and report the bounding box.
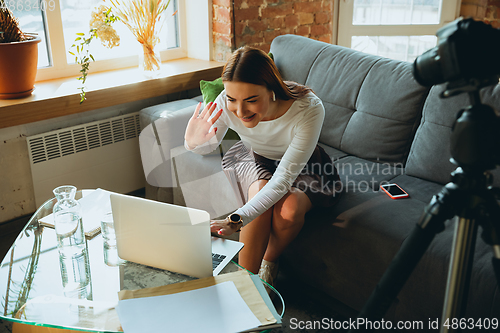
[406,85,500,186]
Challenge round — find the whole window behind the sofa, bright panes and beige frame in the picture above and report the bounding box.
[338,0,460,62]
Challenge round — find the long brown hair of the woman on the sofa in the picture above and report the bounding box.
[222,46,312,100]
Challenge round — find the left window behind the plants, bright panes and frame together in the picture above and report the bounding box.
[6,0,187,80]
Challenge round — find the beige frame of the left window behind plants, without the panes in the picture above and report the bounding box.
[36,0,189,81]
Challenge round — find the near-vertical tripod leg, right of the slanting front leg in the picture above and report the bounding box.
[441,218,478,333]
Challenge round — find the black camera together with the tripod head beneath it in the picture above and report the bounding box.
[413,18,500,170]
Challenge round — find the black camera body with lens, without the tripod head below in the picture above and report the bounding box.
[413,18,500,97]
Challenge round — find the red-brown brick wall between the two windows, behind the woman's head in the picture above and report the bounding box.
[213,0,333,61]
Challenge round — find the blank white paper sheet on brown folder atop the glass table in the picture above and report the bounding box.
[116,281,260,333]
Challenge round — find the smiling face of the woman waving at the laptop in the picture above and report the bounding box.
[224,81,272,128]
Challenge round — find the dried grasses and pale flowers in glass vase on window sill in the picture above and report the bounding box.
[69,0,176,104]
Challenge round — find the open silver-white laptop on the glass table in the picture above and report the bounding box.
[110,193,243,278]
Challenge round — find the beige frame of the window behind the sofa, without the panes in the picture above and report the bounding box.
[335,0,461,48]
